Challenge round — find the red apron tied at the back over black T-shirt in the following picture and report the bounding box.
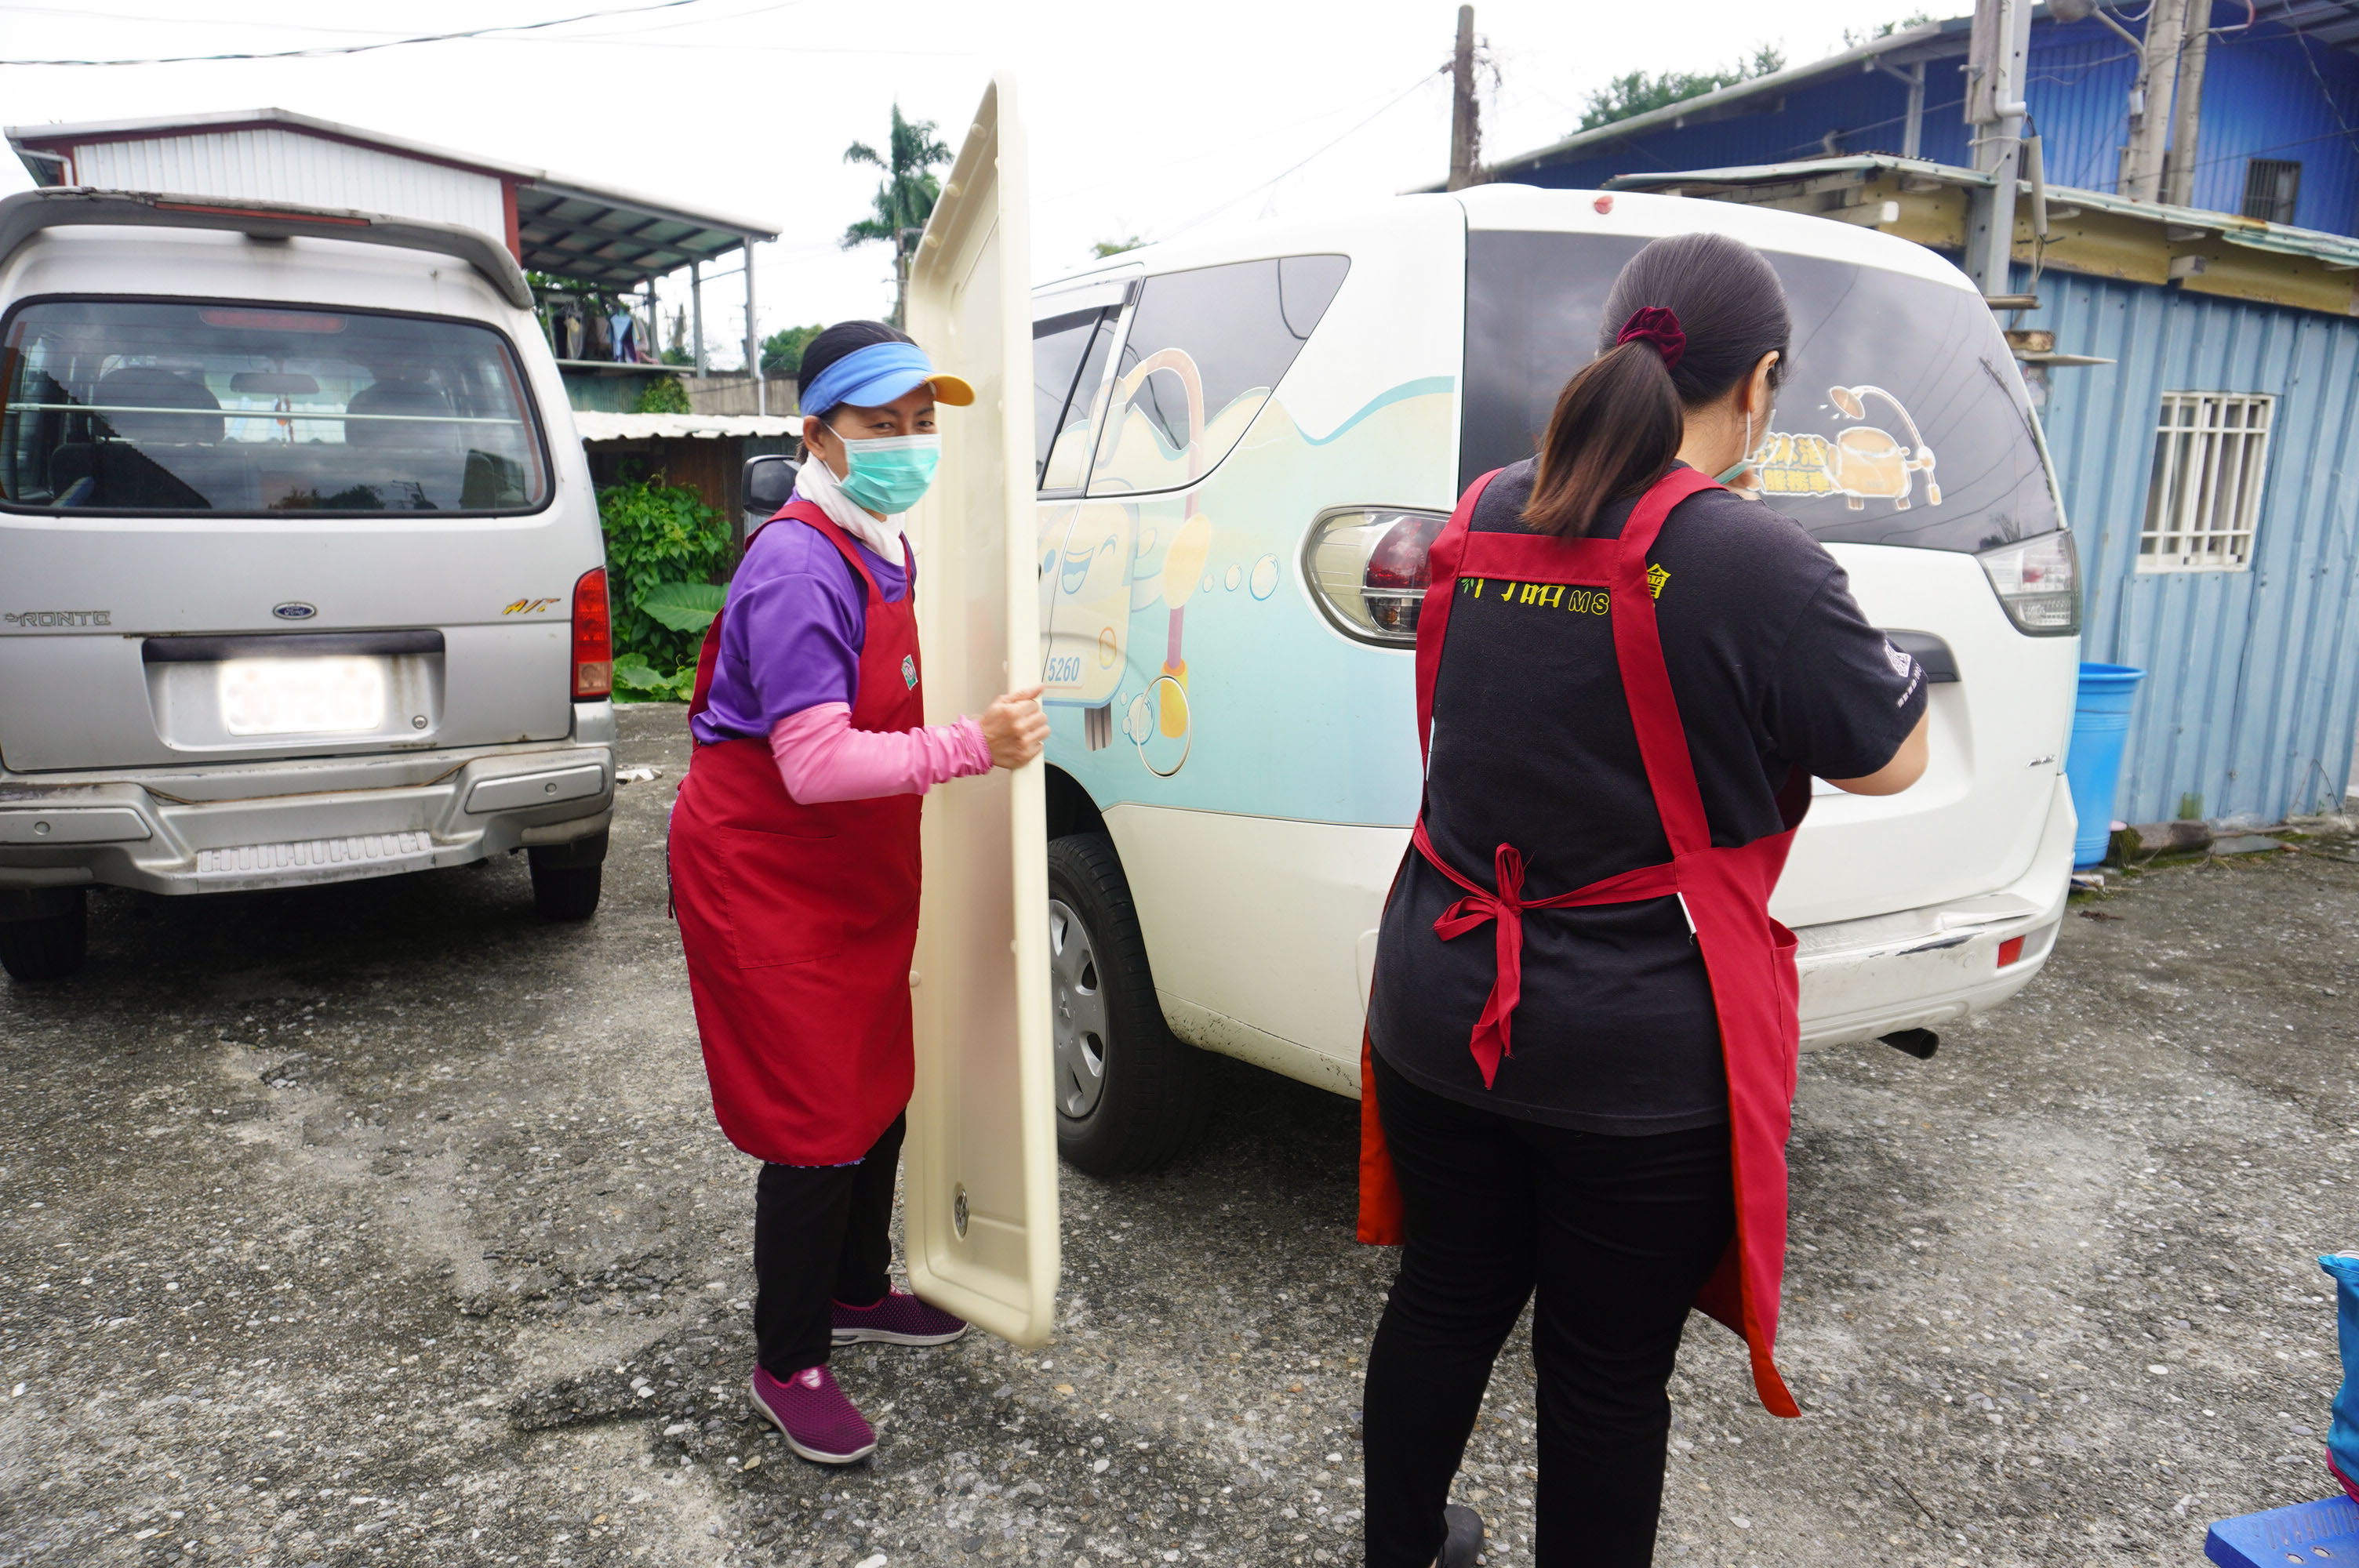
[1359,469,1809,1415]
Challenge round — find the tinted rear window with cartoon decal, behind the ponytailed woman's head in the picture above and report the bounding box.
[1458,231,2064,552]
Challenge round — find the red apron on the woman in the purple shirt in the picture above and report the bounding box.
[670,500,925,1165]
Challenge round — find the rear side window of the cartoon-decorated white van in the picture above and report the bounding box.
[1090,255,1352,495]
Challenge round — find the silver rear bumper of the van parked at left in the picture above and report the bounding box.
[0,702,613,894]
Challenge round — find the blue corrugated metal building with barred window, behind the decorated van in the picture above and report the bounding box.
[1486,0,2359,823]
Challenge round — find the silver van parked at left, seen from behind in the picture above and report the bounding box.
[0,187,616,981]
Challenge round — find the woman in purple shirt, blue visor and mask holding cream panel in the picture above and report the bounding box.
[670,321,1048,1465]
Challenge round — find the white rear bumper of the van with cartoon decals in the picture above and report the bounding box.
[1795,775,2074,1049]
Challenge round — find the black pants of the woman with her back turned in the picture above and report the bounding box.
[1364,1056,1736,1568]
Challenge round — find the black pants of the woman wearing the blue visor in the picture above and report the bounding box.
[753,1116,908,1377]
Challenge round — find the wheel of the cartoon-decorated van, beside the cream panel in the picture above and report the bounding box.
[1048,833,1210,1177]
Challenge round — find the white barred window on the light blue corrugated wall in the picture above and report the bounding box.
[2137,391,2277,571]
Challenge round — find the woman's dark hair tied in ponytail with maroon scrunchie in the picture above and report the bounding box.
[1524,234,1790,538]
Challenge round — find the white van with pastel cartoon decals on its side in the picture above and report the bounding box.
[1034,187,2081,1172]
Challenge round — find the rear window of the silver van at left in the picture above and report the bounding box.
[0,299,550,517]
